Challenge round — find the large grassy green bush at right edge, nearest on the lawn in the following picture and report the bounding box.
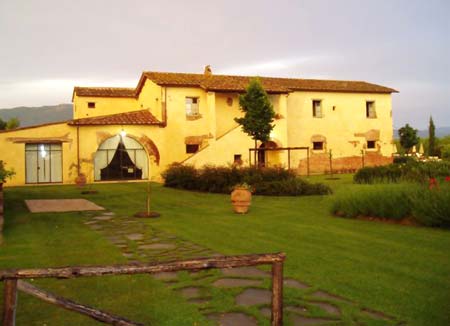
[332,181,450,228]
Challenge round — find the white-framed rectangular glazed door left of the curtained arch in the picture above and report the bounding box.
[25,143,62,183]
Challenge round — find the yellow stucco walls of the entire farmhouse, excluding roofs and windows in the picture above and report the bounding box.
[0,74,393,186]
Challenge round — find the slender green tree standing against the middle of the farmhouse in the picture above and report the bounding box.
[234,78,275,163]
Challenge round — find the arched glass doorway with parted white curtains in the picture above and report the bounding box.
[94,135,148,181]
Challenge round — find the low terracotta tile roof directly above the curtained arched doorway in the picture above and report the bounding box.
[68,110,161,126]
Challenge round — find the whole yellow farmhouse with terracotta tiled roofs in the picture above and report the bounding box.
[0,66,396,185]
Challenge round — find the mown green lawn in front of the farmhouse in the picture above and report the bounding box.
[0,176,450,325]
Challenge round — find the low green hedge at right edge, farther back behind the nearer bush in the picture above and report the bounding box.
[353,161,450,184]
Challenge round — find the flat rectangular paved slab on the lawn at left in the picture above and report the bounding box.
[25,199,105,213]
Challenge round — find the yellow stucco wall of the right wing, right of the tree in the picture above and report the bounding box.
[287,92,393,166]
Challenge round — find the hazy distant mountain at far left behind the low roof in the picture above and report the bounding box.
[0,104,72,127]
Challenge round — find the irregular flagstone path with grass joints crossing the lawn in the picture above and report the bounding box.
[84,212,404,326]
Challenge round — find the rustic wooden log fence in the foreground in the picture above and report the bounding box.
[0,253,285,326]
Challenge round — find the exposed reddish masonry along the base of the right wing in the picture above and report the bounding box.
[298,152,393,175]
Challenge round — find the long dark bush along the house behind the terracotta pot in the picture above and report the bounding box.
[163,164,331,196]
